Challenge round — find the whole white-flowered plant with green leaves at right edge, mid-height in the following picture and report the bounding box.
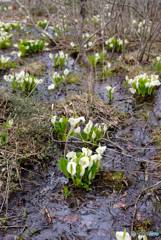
[126,73,161,97]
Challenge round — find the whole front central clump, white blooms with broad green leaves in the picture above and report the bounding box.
[59,146,106,190]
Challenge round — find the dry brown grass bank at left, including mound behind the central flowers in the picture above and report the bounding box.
[0,89,122,212]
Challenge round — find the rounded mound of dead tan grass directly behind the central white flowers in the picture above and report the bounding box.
[54,94,119,127]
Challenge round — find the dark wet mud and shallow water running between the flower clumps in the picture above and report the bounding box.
[0,27,161,240]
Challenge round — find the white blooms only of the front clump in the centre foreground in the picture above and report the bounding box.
[66,146,106,176]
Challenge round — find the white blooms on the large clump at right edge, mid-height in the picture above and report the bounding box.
[126,73,161,94]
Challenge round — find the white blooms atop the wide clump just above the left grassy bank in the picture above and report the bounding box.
[4,71,43,86]
